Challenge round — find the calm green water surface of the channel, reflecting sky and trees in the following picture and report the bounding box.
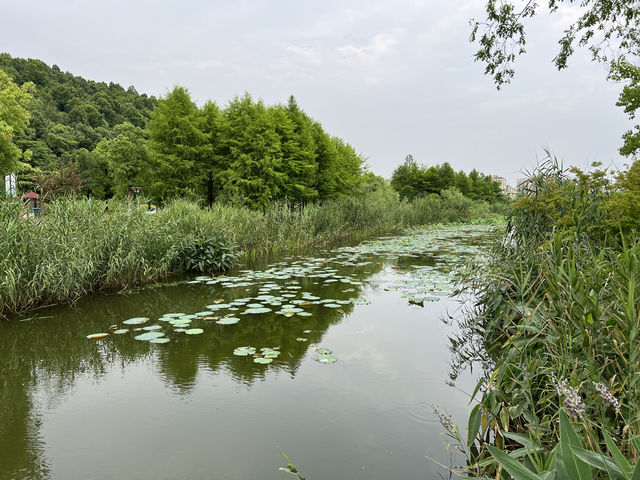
[0,228,488,480]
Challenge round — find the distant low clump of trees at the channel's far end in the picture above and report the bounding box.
[391,155,503,203]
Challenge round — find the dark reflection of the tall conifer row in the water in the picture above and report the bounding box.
[158,262,382,390]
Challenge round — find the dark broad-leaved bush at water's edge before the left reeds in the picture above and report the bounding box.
[182,237,238,273]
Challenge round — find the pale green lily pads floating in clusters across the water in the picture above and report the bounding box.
[87,227,486,364]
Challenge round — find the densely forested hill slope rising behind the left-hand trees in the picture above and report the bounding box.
[0,53,156,188]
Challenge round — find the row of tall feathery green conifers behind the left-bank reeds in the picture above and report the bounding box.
[148,87,364,209]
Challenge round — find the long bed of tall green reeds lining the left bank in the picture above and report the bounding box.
[0,190,495,315]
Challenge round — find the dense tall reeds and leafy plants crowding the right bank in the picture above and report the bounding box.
[436,159,640,480]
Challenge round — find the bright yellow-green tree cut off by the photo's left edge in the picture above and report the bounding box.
[0,70,34,176]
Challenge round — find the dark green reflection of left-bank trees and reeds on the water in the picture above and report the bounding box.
[0,253,383,479]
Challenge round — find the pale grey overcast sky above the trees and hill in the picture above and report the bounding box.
[0,0,631,185]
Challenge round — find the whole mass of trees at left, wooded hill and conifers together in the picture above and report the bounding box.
[0,54,364,209]
